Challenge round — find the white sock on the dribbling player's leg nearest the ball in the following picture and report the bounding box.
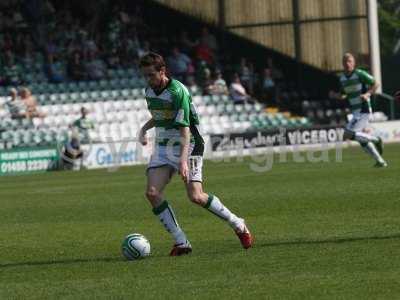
[153,201,187,244]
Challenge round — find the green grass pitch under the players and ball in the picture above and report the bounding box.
[0,145,400,299]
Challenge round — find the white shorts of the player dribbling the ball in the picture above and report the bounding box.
[147,145,203,182]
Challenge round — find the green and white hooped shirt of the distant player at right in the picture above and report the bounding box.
[339,69,375,113]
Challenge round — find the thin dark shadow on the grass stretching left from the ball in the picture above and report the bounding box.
[0,257,124,269]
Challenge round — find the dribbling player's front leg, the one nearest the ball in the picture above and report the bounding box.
[146,165,192,255]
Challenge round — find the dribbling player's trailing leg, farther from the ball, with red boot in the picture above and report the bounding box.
[186,156,253,249]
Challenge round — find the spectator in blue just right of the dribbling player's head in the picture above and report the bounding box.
[167,47,194,83]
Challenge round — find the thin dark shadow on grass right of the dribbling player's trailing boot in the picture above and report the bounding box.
[257,233,400,247]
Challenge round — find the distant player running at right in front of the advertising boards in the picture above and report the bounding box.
[330,53,387,167]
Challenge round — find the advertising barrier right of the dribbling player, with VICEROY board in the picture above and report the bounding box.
[205,121,400,161]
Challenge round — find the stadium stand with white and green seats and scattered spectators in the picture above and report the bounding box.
[0,1,340,148]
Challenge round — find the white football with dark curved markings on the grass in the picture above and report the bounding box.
[122,233,150,260]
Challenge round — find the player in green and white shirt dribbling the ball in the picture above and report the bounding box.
[139,52,253,256]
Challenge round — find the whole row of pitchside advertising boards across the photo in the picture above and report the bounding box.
[0,121,400,175]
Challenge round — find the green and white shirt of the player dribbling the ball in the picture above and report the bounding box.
[146,79,204,148]
